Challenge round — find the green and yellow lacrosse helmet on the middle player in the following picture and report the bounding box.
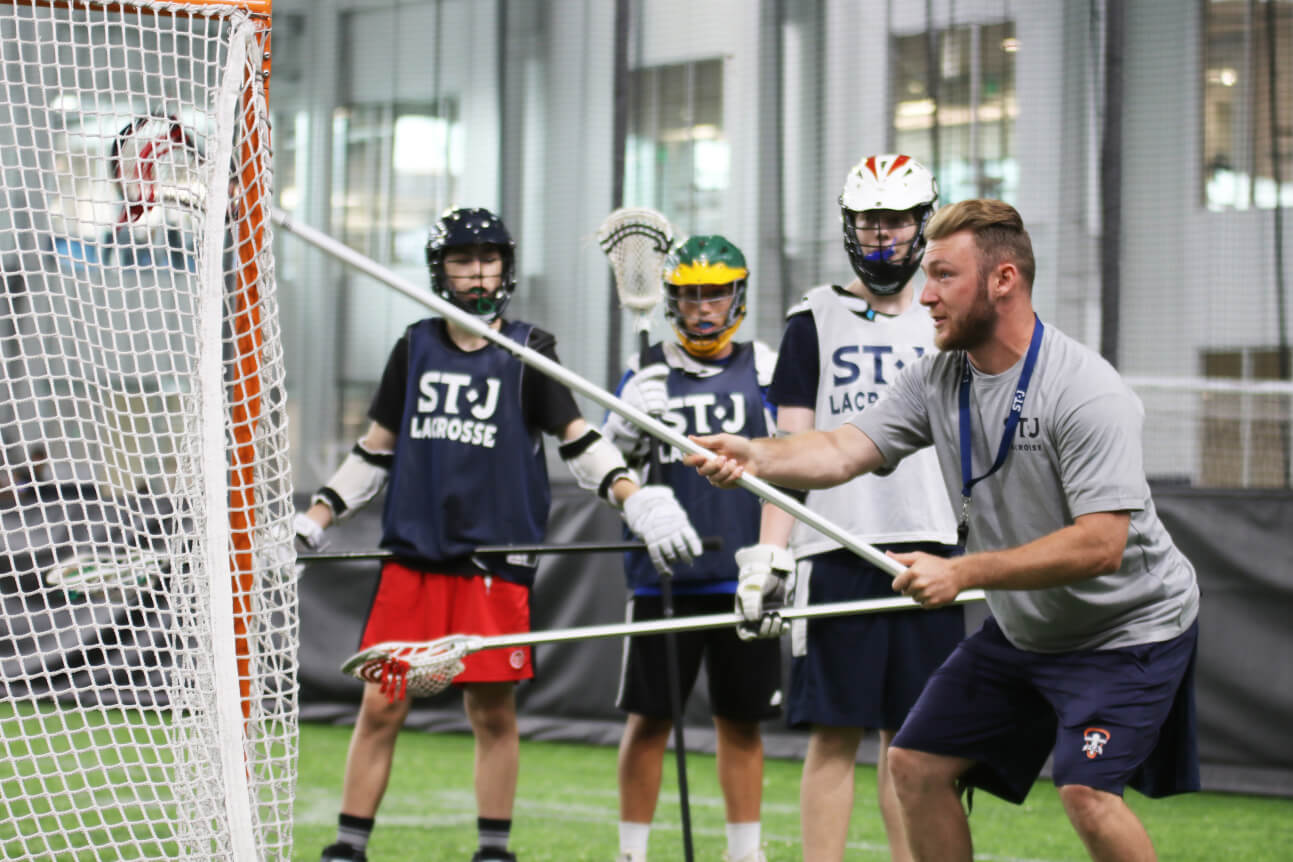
[665,234,750,359]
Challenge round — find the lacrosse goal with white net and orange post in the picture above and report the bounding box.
[0,0,297,859]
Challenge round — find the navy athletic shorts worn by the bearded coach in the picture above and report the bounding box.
[893,618,1199,804]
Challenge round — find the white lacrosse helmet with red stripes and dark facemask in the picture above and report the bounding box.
[839,154,939,296]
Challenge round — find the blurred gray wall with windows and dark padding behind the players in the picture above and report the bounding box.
[257,0,1293,791]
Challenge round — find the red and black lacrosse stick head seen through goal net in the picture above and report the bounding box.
[109,114,207,224]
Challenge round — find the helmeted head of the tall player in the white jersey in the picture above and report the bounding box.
[839,155,939,296]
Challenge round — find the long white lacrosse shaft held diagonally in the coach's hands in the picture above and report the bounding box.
[270,208,984,599]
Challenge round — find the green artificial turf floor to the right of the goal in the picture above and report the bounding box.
[294,725,1293,862]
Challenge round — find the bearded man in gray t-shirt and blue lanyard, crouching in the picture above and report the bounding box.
[687,200,1199,861]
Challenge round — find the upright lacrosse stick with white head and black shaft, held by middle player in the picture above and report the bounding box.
[597,207,692,859]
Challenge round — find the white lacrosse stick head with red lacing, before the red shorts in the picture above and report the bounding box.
[341,635,480,700]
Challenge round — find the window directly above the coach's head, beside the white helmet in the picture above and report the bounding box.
[891,21,1019,202]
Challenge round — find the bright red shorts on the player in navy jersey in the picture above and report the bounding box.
[359,562,534,684]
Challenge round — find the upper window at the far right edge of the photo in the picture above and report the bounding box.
[1202,0,1293,209]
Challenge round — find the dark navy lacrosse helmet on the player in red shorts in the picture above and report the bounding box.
[427,207,516,323]
